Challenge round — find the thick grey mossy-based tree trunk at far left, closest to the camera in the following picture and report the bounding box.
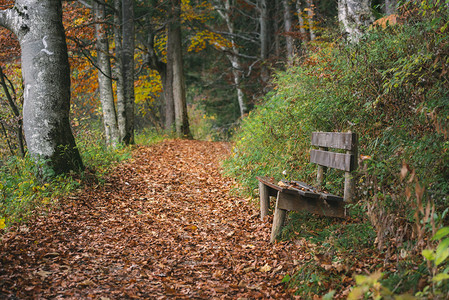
[0,0,83,176]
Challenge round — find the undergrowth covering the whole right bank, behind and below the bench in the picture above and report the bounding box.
[223,1,449,298]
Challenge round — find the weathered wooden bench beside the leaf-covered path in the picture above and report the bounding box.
[257,132,358,242]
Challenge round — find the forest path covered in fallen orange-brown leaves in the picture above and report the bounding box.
[0,140,304,300]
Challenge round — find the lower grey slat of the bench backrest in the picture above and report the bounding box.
[310,149,355,171]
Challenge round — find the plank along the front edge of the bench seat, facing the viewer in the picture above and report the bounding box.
[276,193,346,218]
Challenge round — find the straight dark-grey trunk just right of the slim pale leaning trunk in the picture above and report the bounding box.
[120,0,135,145]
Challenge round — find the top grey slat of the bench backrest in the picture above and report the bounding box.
[312,132,357,150]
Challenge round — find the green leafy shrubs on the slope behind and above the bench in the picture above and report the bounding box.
[224,3,449,220]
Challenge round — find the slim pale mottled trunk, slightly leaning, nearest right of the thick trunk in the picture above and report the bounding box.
[93,2,120,148]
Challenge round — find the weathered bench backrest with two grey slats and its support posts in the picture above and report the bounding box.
[310,132,358,202]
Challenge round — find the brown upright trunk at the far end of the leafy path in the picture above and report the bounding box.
[167,0,191,138]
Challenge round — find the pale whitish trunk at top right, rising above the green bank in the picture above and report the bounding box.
[338,0,374,43]
